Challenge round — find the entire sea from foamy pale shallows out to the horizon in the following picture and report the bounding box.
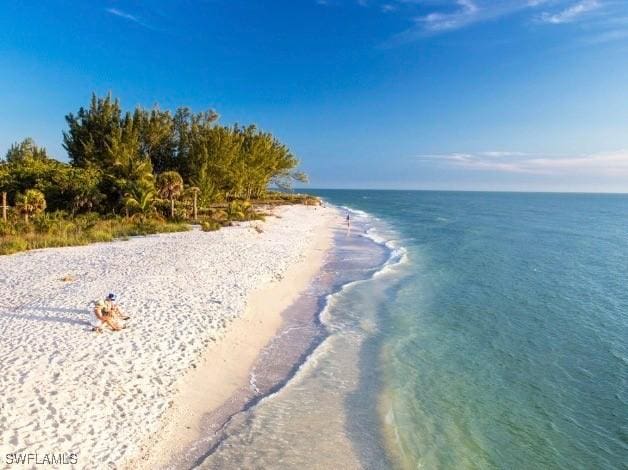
[198,190,628,469]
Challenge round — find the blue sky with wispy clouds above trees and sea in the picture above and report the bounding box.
[0,0,628,192]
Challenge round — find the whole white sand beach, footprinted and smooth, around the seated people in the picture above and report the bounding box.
[0,206,337,468]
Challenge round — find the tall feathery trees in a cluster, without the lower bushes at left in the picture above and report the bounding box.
[63,95,306,211]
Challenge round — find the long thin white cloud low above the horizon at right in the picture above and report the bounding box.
[418,150,628,177]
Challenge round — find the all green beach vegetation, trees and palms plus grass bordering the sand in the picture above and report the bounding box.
[0,94,316,254]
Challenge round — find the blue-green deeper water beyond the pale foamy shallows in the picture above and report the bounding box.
[319,191,628,468]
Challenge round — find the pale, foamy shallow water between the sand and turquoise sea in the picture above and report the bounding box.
[198,211,390,468]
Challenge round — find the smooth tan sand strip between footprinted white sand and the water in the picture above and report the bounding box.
[127,207,334,470]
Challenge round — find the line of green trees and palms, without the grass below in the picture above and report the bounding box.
[0,95,306,218]
